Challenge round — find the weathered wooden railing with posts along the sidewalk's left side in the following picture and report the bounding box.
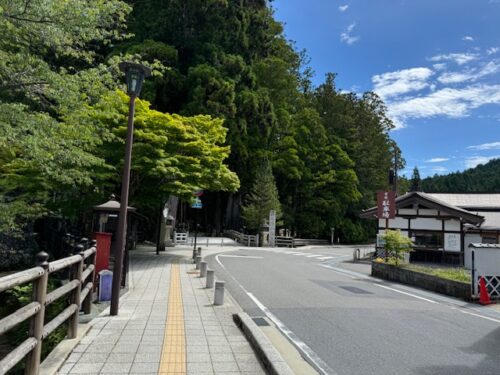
[0,239,96,375]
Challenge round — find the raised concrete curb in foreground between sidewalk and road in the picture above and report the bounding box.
[233,312,294,375]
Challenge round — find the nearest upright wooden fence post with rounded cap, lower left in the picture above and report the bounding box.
[24,251,49,375]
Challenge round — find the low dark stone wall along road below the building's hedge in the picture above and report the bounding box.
[372,262,472,301]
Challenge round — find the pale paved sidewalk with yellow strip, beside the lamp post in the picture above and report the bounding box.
[58,247,265,375]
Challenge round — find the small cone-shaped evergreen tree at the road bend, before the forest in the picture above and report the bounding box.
[242,163,282,231]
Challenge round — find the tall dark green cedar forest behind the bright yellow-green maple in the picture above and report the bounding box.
[123,0,400,241]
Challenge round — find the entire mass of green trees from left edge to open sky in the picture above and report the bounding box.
[0,0,397,264]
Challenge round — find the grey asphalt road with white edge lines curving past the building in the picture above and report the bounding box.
[205,247,500,375]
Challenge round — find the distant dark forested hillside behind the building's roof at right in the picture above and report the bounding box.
[421,159,500,193]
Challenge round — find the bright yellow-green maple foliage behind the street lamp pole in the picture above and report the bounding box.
[79,91,239,207]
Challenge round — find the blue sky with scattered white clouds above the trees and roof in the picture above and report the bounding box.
[271,0,500,176]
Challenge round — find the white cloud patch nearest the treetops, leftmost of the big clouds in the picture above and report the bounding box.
[372,68,433,98]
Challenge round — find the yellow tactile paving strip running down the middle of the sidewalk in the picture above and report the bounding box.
[158,264,186,375]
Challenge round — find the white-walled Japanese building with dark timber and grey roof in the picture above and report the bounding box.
[360,191,500,268]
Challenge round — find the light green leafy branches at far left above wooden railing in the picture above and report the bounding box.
[0,0,130,235]
